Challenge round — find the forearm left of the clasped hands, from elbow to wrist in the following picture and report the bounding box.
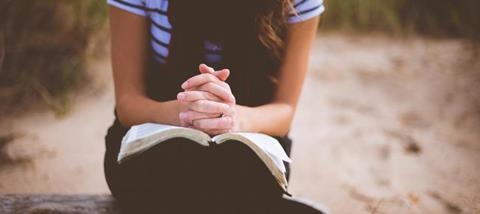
[116,95,180,127]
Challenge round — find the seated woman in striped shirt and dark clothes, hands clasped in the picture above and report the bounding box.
[105,0,323,213]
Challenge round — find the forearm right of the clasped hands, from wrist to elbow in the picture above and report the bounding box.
[237,103,294,136]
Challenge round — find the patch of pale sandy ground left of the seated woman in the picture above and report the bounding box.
[0,61,114,193]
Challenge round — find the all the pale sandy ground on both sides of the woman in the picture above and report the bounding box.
[0,34,480,213]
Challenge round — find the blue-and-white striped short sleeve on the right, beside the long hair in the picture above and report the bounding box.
[288,0,325,23]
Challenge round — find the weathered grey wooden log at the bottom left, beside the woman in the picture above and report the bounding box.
[0,194,120,214]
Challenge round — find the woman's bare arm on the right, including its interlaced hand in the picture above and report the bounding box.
[181,17,319,136]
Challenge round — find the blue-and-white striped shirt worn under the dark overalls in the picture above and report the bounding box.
[108,0,325,63]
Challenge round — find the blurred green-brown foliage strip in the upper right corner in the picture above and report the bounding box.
[322,0,480,42]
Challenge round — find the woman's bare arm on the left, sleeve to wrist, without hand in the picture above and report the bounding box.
[110,7,179,126]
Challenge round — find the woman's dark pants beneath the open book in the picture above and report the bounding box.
[105,118,319,213]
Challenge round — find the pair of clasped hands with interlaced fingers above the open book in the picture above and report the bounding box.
[177,64,240,135]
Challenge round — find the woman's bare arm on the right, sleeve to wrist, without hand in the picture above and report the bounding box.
[237,17,319,136]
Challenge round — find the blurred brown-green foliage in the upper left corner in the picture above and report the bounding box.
[0,0,107,114]
